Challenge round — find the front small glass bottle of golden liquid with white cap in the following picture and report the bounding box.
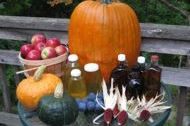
[68,69,87,99]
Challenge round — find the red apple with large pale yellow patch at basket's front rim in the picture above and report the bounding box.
[41,47,57,59]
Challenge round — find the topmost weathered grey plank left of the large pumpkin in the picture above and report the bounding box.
[0,16,69,31]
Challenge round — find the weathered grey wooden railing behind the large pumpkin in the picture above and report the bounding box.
[0,16,190,126]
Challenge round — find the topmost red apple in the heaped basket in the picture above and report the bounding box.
[31,33,46,45]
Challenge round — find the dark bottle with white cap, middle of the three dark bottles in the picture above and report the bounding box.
[128,56,145,98]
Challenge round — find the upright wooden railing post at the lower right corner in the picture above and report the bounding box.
[176,87,187,126]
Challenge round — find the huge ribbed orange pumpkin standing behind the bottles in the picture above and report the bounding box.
[69,0,141,80]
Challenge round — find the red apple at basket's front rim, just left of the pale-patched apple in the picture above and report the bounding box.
[26,50,41,60]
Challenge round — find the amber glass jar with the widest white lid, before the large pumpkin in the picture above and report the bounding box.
[84,63,102,94]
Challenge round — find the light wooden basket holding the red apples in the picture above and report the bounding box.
[18,53,68,77]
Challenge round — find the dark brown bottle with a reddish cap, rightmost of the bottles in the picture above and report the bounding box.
[144,55,162,100]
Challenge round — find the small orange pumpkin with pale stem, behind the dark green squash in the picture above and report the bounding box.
[16,66,62,109]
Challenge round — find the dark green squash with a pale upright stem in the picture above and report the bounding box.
[38,84,78,126]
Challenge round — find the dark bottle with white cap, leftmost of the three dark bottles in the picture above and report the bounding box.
[110,54,128,93]
